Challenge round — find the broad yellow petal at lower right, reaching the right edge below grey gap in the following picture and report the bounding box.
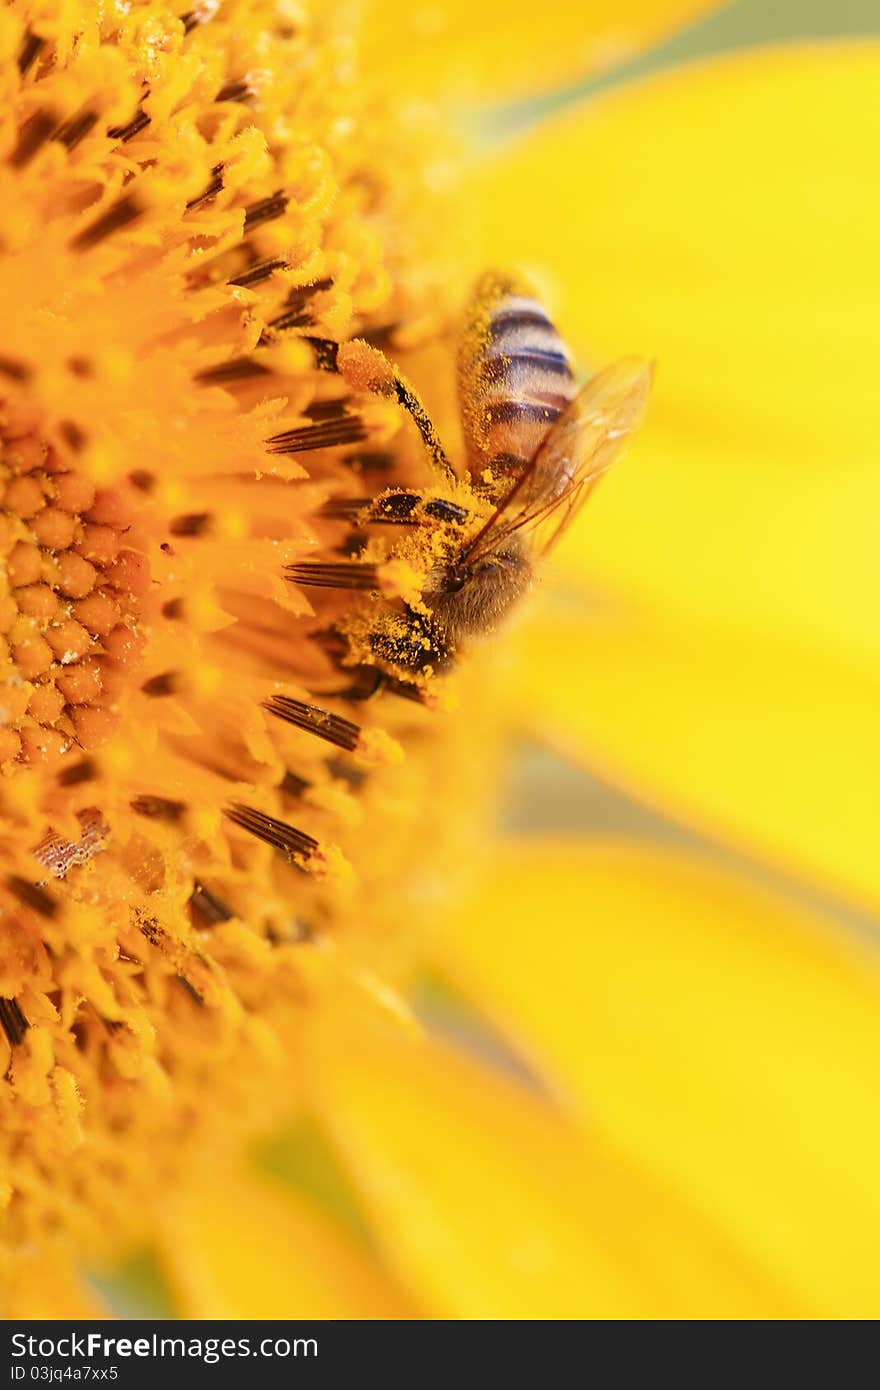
[436,840,880,1318]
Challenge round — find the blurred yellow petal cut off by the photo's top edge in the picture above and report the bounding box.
[355,0,717,101]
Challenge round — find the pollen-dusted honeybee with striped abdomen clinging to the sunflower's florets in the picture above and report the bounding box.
[289,272,652,687]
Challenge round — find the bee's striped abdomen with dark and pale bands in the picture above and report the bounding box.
[459,277,578,480]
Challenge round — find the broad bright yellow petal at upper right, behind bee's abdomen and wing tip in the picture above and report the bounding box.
[474,40,880,444]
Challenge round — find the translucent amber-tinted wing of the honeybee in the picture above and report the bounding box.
[468,357,653,555]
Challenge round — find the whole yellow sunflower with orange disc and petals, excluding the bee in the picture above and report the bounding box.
[0,0,880,1319]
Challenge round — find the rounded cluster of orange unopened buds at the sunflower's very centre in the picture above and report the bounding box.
[0,410,145,773]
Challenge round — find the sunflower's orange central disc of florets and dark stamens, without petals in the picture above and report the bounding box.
[0,0,481,1308]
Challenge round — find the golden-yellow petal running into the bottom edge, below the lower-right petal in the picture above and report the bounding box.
[303,1031,804,1319]
